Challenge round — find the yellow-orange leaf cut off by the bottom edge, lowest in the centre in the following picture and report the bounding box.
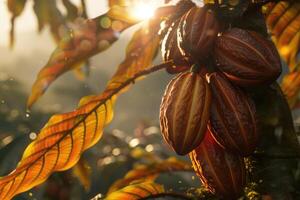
[104,181,164,200]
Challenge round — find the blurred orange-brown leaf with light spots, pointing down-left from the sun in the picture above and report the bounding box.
[27,7,138,108]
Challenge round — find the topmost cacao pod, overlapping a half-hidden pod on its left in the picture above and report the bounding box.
[177,7,219,61]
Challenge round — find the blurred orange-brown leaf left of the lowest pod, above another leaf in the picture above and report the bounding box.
[108,157,193,194]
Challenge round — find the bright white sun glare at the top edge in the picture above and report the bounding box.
[132,1,157,20]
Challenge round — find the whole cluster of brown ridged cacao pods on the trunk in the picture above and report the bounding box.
[160,6,281,199]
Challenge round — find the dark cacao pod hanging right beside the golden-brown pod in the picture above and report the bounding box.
[208,72,258,156]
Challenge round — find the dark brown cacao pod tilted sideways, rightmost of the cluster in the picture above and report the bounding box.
[214,28,282,86]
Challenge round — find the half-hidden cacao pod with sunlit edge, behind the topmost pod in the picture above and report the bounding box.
[161,21,190,74]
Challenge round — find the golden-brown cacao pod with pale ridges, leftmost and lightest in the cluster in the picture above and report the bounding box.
[160,72,211,155]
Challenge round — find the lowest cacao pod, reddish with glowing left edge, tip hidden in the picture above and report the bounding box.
[189,130,246,200]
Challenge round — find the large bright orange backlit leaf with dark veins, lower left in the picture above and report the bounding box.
[0,96,114,200]
